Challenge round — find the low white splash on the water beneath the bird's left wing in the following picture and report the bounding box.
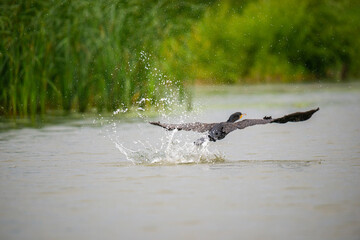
[98,114,224,165]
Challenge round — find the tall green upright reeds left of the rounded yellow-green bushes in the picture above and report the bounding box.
[0,0,211,117]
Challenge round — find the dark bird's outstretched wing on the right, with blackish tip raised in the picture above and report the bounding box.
[228,108,319,133]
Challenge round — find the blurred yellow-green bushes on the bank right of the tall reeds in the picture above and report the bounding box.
[163,0,360,83]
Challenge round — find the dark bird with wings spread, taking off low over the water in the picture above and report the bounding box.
[150,108,319,145]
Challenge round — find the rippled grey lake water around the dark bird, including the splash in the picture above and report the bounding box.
[0,83,360,240]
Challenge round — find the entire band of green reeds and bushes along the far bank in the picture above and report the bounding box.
[0,0,360,117]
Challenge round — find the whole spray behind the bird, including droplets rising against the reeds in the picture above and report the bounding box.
[99,52,224,164]
